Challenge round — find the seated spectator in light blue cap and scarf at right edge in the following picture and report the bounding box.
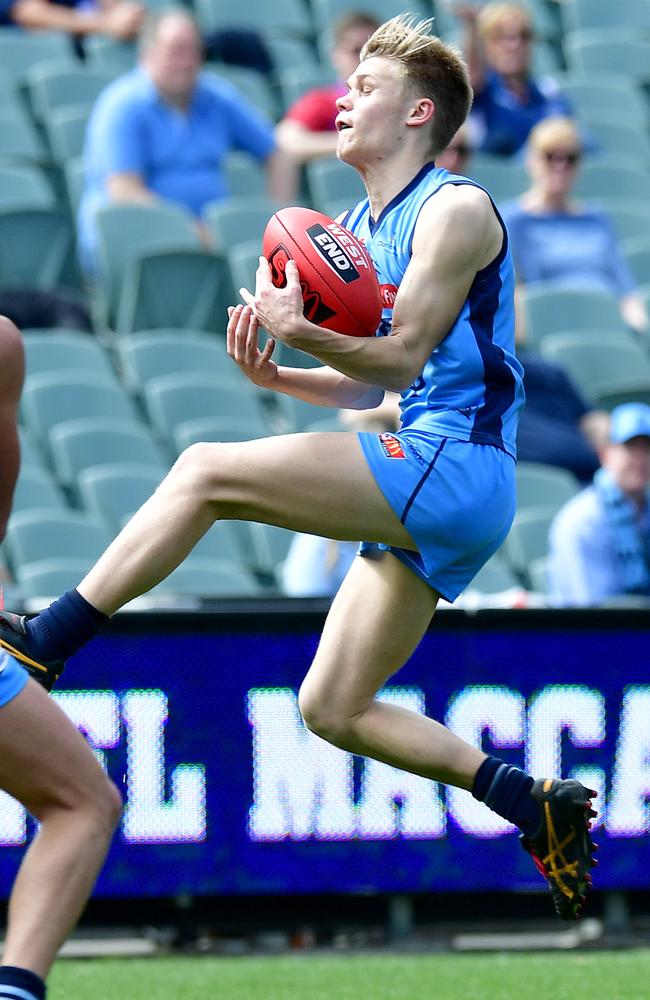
[549,403,650,606]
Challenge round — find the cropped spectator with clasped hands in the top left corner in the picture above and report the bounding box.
[0,0,145,41]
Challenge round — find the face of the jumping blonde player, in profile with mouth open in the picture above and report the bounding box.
[336,56,414,165]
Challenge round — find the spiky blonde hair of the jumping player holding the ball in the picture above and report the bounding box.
[360,14,474,154]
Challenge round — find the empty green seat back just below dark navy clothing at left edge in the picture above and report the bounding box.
[23,328,119,385]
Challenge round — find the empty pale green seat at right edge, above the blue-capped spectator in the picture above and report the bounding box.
[539,331,650,409]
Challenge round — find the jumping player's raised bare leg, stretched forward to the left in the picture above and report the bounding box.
[78,433,415,615]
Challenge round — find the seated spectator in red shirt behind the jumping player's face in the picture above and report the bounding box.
[276,12,379,165]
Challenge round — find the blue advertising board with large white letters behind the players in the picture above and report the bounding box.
[0,601,650,897]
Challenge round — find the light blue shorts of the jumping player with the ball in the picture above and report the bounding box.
[359,430,516,601]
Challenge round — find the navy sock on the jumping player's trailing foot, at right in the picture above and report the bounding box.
[472,757,539,837]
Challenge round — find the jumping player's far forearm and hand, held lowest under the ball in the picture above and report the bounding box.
[226,305,384,410]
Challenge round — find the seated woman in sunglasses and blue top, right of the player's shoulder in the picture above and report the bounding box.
[501,118,648,331]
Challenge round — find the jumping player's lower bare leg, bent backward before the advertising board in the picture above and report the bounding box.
[300,553,485,789]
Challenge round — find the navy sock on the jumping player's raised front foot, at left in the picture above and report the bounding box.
[25,590,108,663]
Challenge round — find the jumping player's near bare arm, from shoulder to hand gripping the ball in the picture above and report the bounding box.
[241,185,503,391]
